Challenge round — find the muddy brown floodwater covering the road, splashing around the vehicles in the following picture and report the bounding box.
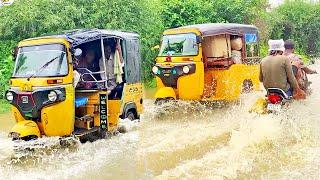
[0,62,320,179]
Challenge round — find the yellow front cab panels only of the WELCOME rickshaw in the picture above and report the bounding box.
[11,38,75,137]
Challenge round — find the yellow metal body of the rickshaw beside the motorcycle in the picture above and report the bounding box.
[155,28,260,101]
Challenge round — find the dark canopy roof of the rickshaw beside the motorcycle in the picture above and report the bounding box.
[171,23,258,36]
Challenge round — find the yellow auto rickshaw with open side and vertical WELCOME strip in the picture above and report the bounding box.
[6,29,143,141]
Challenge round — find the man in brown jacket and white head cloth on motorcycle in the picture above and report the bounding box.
[259,39,305,99]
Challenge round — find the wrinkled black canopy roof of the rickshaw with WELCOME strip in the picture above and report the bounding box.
[21,29,139,47]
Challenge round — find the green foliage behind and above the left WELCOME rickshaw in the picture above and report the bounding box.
[0,0,163,94]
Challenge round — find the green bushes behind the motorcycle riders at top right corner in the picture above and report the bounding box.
[271,0,320,56]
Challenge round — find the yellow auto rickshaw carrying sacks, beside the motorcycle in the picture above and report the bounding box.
[152,23,260,102]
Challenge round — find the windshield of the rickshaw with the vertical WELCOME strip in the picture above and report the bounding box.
[13,44,68,77]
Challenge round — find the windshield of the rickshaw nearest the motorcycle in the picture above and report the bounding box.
[159,33,198,56]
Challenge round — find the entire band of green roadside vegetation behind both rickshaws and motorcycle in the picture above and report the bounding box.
[0,0,320,100]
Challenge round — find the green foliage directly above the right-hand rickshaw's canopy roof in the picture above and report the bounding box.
[161,0,268,28]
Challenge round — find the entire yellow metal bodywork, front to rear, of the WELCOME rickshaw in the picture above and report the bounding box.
[11,37,143,137]
